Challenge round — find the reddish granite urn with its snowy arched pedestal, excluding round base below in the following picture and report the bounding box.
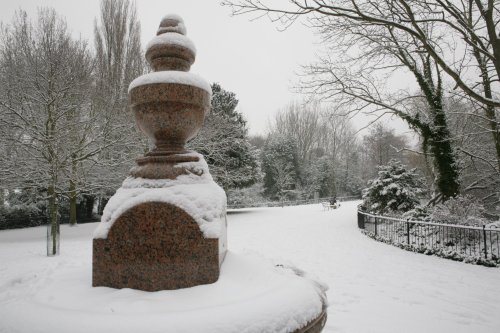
[92,15,226,291]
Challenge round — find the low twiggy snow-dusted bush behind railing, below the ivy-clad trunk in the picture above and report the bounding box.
[431,195,489,226]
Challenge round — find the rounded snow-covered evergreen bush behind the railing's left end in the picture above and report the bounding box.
[362,160,424,214]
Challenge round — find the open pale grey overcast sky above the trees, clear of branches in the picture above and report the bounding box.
[0,0,324,134]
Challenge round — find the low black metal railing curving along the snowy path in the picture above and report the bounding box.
[358,210,500,261]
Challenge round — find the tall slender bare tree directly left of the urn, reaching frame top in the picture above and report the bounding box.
[92,0,148,210]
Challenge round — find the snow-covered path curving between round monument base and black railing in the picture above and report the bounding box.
[228,202,500,333]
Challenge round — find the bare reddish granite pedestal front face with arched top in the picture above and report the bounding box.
[93,202,219,291]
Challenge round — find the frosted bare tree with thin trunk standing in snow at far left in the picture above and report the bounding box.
[0,9,95,255]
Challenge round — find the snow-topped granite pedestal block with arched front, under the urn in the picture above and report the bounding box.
[92,152,227,291]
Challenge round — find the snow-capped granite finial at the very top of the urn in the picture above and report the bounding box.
[146,14,196,72]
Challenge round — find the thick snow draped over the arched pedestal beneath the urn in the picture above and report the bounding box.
[94,152,227,270]
